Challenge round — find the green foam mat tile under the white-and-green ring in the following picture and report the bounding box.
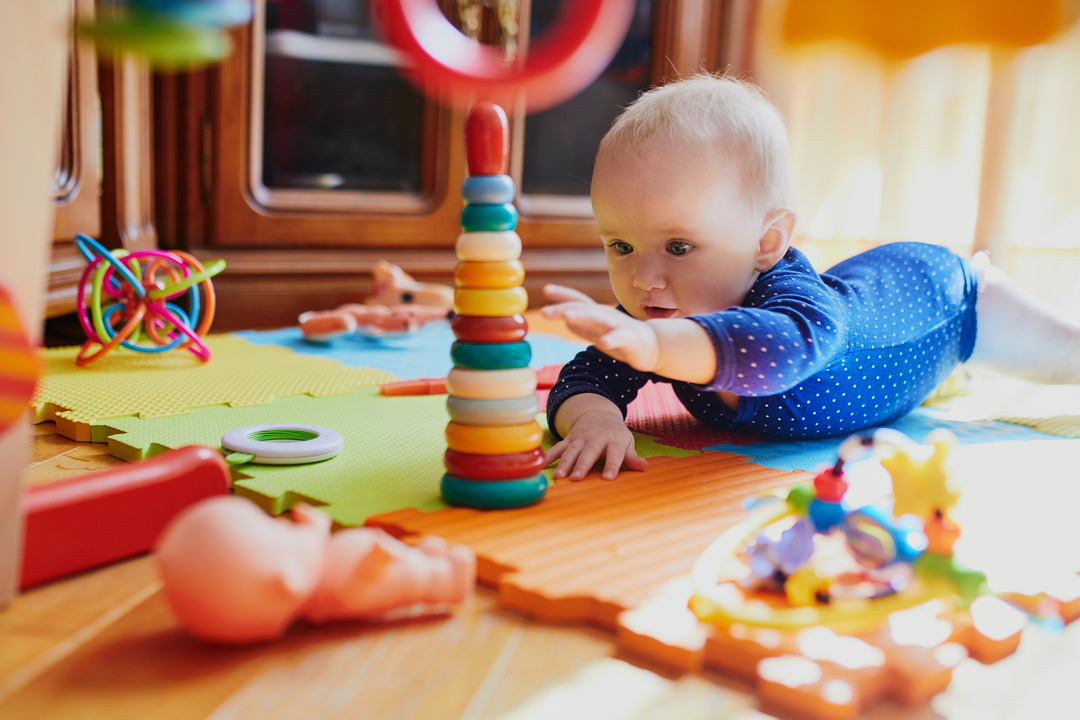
[99,388,700,526]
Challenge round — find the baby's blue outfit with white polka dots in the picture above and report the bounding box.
[548,243,977,437]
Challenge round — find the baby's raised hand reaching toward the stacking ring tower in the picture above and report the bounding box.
[541,285,660,372]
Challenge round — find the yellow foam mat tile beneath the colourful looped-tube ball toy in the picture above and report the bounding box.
[31,335,393,441]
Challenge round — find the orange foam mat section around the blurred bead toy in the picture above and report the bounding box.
[369,440,1080,718]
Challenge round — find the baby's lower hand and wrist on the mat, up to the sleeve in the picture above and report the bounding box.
[544,393,646,480]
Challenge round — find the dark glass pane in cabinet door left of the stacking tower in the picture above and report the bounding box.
[257,0,424,197]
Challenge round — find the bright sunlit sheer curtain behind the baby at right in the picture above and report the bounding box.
[732,0,1080,315]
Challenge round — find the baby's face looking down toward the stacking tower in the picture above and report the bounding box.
[592,140,766,320]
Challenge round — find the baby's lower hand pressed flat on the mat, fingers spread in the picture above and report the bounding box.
[544,412,646,480]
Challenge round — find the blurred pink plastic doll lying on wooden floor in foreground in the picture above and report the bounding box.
[157,495,476,644]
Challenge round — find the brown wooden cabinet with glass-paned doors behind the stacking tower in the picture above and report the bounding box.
[147,0,723,330]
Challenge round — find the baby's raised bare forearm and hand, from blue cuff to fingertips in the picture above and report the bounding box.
[543,285,716,384]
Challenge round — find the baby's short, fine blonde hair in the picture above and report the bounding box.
[598,73,793,220]
